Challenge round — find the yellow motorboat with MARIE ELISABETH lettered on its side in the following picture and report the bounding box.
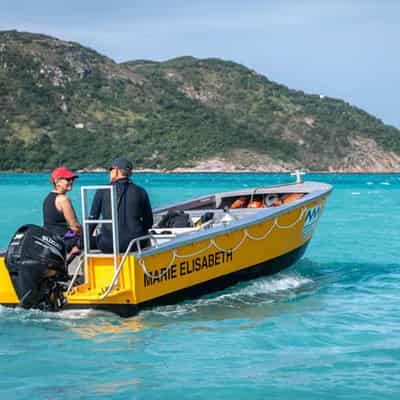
[0,176,332,317]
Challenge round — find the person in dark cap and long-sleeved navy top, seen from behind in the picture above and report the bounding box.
[89,158,153,253]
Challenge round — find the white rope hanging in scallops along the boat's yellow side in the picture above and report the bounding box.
[139,208,305,280]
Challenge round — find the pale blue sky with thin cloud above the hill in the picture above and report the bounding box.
[0,0,400,128]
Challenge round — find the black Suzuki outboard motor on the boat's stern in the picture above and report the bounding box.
[5,225,67,311]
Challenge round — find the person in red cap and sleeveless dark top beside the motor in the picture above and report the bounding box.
[43,167,82,254]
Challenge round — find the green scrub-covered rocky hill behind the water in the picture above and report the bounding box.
[0,31,400,171]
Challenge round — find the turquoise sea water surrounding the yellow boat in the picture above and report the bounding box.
[0,174,400,400]
